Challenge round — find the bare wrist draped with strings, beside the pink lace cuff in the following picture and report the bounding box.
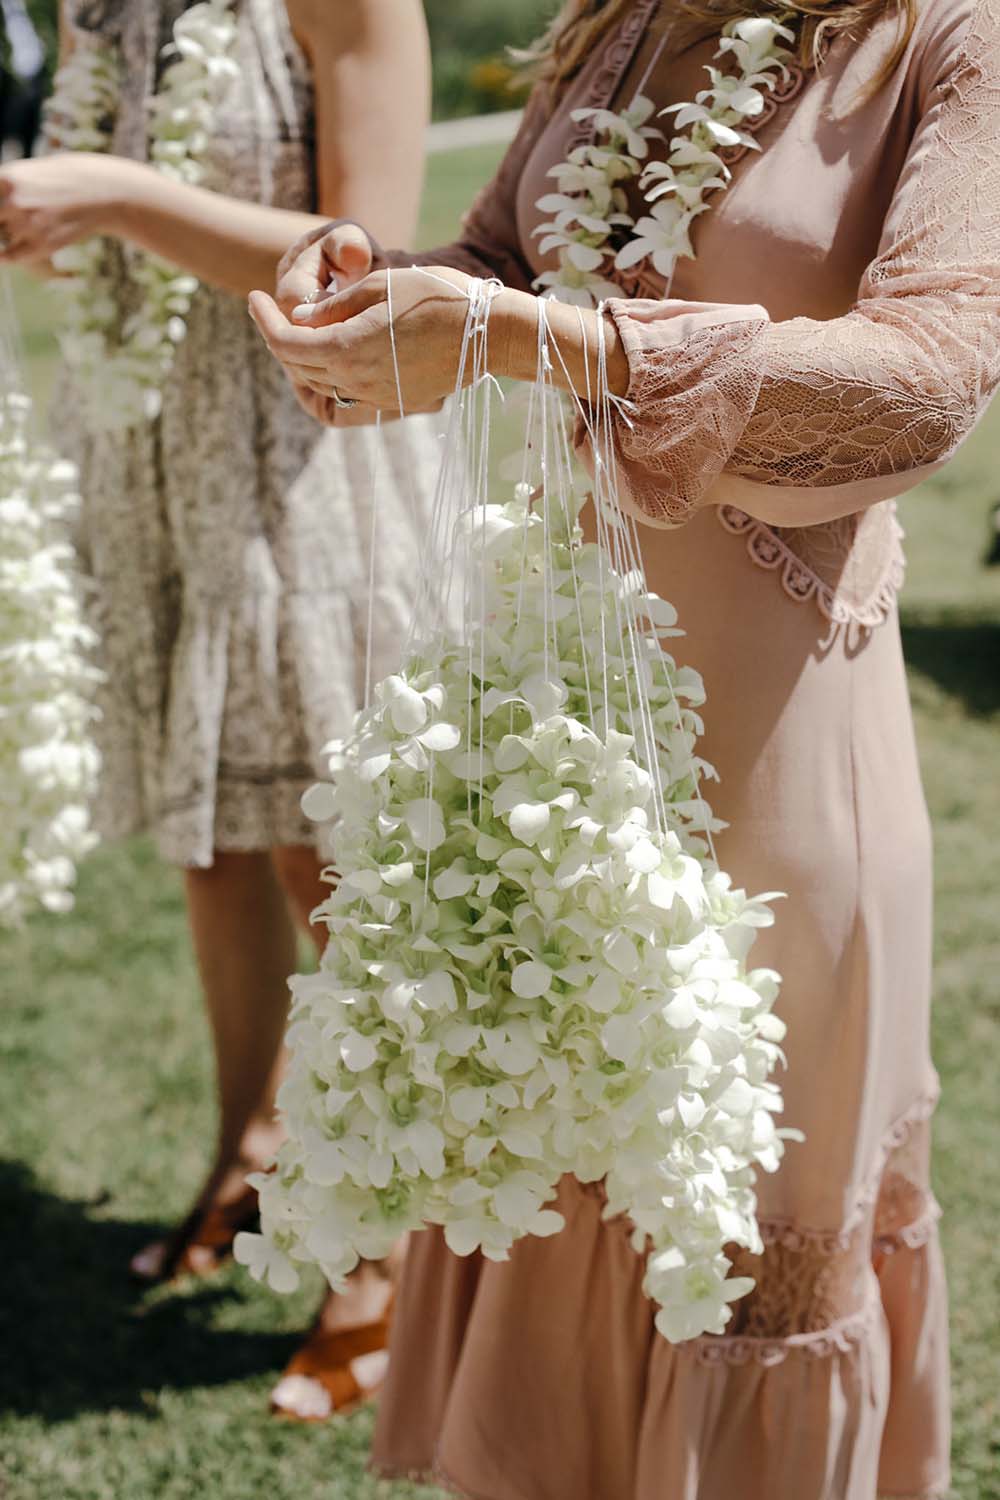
[490,290,630,401]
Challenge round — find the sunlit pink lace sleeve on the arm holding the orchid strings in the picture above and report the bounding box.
[610,0,1000,527]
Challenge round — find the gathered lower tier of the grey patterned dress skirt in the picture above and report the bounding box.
[96,564,419,869]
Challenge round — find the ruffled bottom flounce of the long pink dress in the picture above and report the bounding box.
[372,1184,948,1500]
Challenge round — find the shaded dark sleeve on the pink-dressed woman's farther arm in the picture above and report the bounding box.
[384,86,549,291]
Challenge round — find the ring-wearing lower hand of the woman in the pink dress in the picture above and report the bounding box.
[250,266,469,426]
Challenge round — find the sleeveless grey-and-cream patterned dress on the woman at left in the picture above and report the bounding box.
[57,0,435,866]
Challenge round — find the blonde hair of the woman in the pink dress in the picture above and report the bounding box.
[529,0,916,96]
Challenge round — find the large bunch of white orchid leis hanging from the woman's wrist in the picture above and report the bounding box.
[237,486,783,1340]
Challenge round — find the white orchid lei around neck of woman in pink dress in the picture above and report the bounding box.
[534,17,795,308]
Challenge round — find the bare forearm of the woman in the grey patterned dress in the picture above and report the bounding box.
[107,161,324,297]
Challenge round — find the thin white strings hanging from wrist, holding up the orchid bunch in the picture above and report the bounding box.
[366,272,717,864]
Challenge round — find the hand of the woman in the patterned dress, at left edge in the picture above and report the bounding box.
[0,152,142,263]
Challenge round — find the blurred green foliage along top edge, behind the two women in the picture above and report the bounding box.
[5,0,558,120]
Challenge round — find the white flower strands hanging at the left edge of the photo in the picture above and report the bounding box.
[0,393,97,923]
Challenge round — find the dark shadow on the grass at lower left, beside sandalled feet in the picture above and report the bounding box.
[0,1163,298,1422]
